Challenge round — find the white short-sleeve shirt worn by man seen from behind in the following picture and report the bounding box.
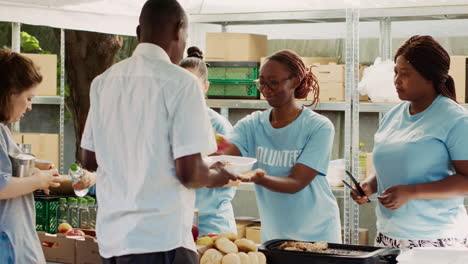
[81,43,216,258]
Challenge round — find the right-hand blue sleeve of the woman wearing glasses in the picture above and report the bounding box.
[296,120,335,176]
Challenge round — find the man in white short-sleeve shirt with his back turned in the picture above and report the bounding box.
[74,0,236,263]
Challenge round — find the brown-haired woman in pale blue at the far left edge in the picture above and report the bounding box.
[0,49,60,264]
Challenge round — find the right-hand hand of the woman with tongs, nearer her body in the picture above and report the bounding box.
[377,185,415,210]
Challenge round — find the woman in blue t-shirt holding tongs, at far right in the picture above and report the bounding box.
[353,36,468,249]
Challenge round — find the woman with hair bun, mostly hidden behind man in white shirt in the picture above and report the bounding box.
[179,47,237,235]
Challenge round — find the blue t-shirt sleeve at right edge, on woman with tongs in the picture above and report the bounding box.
[446,116,468,160]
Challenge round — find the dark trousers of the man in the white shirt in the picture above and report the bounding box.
[102,247,198,264]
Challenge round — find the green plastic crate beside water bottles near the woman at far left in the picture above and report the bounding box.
[34,196,59,234]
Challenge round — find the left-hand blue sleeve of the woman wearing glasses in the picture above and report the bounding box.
[227,116,253,157]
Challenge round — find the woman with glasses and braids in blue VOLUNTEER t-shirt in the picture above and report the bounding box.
[226,50,341,243]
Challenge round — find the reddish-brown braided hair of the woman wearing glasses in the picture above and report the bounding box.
[267,50,320,108]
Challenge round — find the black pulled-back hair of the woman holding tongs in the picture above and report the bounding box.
[394,35,457,102]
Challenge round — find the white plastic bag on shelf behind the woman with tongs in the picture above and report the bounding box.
[359,57,401,103]
